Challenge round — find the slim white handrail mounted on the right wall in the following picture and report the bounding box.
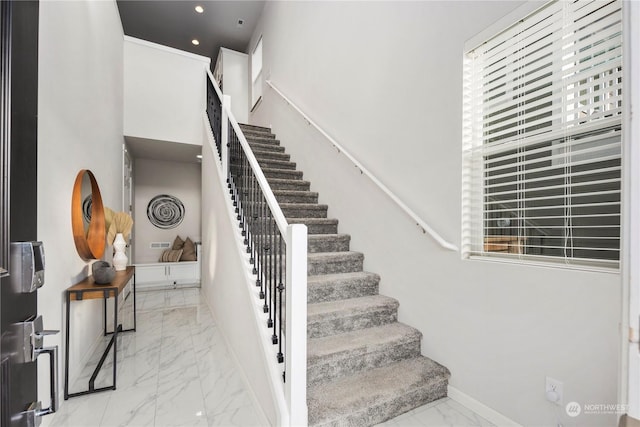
[266,80,458,252]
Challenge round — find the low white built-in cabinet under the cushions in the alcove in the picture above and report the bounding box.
[136,261,200,289]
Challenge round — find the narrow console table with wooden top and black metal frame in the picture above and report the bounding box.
[64,266,136,400]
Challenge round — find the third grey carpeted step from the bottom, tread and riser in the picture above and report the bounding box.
[307,295,398,338]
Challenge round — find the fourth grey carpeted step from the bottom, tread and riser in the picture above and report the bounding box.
[307,271,380,303]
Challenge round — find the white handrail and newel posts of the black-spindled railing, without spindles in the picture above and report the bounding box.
[207,69,308,426]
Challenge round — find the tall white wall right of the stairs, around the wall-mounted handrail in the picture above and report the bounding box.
[248,1,621,426]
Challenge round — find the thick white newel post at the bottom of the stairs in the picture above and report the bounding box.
[285,224,308,426]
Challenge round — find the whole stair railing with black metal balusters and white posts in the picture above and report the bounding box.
[207,70,307,425]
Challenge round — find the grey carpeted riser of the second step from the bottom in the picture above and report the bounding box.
[307,335,420,386]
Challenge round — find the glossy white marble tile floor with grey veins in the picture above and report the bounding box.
[49,288,492,427]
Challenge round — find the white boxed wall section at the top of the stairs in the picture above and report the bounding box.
[213,47,249,123]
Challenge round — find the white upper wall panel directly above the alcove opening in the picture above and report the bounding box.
[124,37,210,145]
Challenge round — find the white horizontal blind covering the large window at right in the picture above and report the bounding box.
[462,1,622,268]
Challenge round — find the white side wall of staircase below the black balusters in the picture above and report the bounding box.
[201,122,276,426]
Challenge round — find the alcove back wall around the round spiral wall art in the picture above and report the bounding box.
[133,158,202,263]
